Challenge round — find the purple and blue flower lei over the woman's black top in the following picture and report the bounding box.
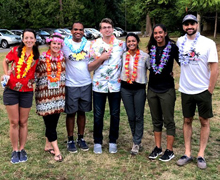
[150,41,171,74]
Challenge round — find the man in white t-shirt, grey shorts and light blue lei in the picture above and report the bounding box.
[62,22,92,153]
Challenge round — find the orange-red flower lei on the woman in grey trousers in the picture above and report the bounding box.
[125,49,140,84]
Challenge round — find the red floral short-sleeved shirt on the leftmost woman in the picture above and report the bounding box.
[6,47,39,92]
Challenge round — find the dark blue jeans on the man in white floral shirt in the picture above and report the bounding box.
[93,91,121,144]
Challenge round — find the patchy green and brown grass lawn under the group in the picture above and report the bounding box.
[0,35,220,180]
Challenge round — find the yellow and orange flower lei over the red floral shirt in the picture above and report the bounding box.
[17,46,34,79]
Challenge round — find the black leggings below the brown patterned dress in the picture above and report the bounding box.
[43,113,60,142]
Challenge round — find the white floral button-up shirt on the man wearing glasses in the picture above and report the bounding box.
[90,38,125,93]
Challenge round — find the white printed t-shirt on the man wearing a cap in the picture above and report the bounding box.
[177,35,218,94]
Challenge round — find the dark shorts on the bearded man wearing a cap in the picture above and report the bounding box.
[181,90,213,119]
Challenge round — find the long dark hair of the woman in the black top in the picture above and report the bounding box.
[147,24,175,53]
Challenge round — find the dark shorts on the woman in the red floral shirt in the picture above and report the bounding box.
[3,88,34,108]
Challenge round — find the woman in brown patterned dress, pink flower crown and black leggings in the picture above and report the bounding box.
[35,33,65,162]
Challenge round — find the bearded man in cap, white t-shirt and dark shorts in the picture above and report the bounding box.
[177,14,218,169]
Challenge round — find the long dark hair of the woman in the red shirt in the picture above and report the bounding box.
[18,29,40,60]
